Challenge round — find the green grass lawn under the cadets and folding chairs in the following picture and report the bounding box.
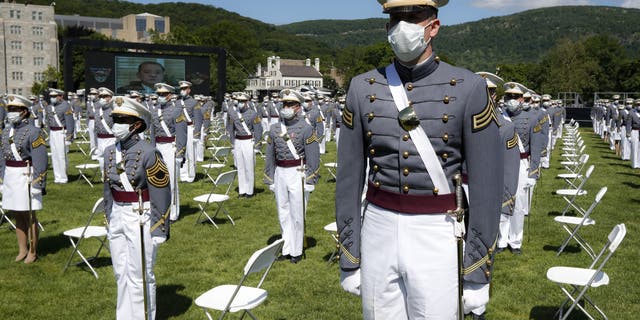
[0,125,640,320]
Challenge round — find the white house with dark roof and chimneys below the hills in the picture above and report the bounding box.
[245,56,323,97]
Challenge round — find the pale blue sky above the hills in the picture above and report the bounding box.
[130,0,640,25]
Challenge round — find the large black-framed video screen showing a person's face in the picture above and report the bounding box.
[85,51,210,95]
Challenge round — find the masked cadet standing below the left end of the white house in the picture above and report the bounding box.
[227,93,262,198]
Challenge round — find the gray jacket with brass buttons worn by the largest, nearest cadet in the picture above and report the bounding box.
[335,55,504,283]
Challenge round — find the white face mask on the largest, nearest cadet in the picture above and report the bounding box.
[387,21,433,62]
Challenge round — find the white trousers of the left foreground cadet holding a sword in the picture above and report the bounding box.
[109,202,166,320]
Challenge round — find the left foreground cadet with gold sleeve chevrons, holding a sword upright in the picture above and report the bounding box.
[104,96,171,319]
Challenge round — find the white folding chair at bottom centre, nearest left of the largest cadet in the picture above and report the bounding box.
[195,239,284,320]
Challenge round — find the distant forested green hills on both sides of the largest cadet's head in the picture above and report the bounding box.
[277,6,640,70]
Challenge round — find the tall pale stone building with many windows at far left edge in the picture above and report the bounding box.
[0,2,59,95]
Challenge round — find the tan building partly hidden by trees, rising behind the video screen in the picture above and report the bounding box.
[55,13,170,43]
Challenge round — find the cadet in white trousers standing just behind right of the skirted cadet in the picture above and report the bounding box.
[46,89,74,183]
